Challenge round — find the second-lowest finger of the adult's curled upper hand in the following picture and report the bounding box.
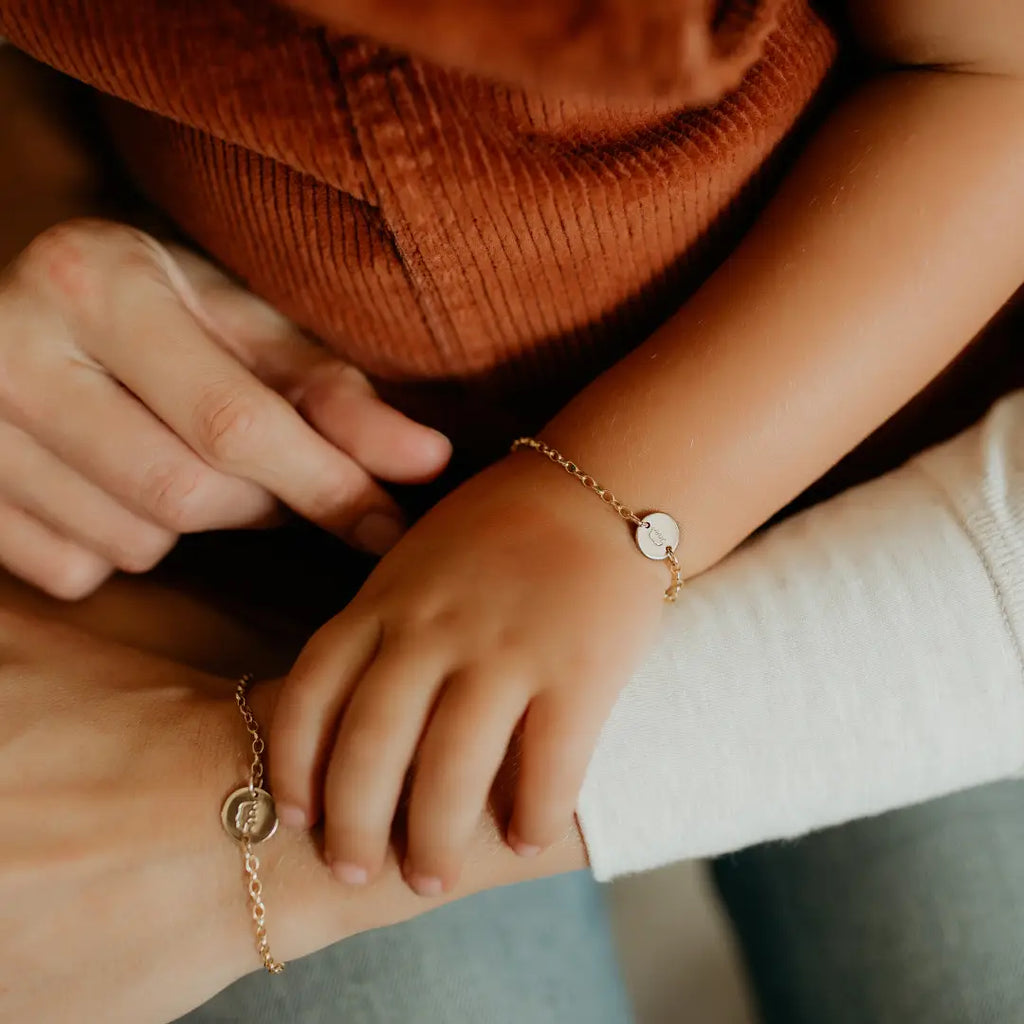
[0,422,177,572]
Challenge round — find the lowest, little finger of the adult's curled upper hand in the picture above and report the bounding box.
[0,499,114,601]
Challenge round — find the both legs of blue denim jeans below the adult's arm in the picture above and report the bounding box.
[182,781,1024,1024]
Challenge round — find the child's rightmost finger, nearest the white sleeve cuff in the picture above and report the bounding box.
[508,694,601,857]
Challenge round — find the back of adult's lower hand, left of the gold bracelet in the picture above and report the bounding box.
[0,609,275,1024]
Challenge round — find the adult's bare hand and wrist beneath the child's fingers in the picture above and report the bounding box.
[0,572,586,1024]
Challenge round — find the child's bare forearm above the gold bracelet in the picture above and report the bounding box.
[546,72,1024,573]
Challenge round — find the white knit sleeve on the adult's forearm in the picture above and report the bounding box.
[578,392,1024,880]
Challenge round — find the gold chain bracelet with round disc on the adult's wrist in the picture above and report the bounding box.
[220,675,285,974]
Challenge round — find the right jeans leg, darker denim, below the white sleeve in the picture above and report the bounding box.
[713,780,1024,1024]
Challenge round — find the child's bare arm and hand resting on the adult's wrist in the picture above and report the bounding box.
[272,0,1024,895]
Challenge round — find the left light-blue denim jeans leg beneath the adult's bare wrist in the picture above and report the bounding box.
[180,871,633,1024]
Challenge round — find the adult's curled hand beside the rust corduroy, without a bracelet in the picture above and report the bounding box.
[0,220,451,599]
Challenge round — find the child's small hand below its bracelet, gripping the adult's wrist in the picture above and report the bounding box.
[269,453,665,895]
